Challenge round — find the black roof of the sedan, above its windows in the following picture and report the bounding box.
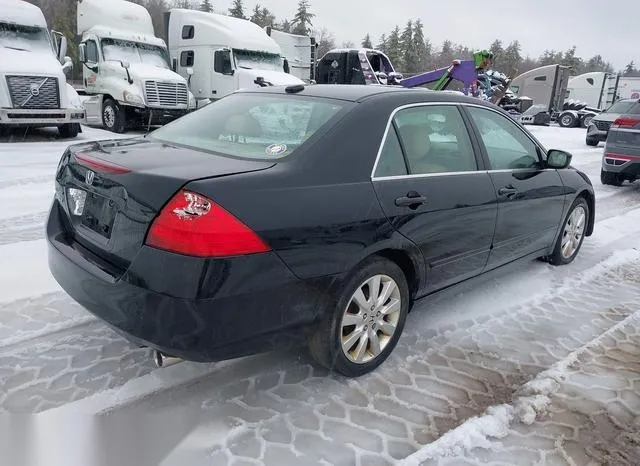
[237,84,490,105]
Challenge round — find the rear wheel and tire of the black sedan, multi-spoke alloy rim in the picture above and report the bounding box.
[309,257,410,377]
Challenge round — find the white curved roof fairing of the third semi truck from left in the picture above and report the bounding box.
[170,8,282,55]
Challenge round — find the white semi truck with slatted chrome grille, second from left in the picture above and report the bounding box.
[77,0,196,133]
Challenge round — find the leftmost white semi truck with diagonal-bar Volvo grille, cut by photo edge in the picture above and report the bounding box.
[0,0,85,137]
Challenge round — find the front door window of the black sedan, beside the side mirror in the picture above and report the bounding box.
[468,107,540,170]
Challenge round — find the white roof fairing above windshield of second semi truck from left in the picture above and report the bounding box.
[77,0,157,36]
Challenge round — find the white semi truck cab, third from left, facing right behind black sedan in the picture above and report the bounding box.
[165,8,304,105]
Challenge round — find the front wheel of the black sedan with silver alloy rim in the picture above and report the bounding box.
[549,197,591,265]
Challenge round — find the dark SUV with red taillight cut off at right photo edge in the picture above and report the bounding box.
[600,114,640,186]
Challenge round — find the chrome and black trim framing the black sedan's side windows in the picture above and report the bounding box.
[370,101,556,181]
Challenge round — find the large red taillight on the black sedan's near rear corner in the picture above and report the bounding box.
[146,191,271,257]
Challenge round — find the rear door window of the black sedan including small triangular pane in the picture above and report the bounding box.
[376,105,478,176]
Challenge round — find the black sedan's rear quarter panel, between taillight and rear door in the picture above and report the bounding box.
[188,93,424,279]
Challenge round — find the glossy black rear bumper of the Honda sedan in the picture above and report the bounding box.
[46,200,327,362]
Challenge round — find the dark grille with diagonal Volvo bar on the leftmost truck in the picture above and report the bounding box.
[7,76,60,109]
